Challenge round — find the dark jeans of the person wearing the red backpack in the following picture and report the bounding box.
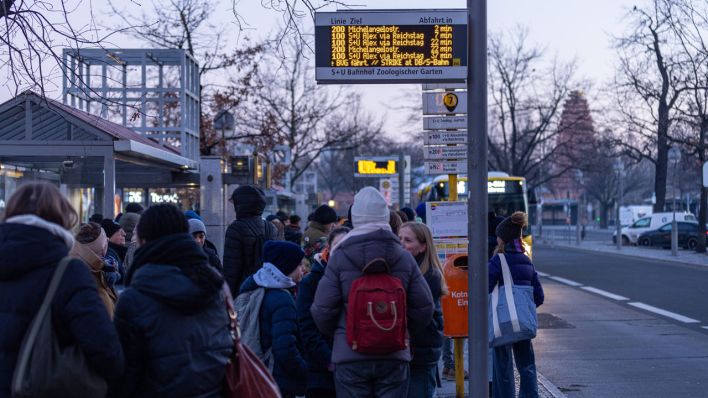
[334,360,410,398]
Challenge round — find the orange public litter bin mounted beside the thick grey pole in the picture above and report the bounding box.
[442,254,469,338]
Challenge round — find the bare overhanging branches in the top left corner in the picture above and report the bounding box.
[0,0,115,96]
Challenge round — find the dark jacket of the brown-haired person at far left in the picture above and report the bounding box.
[0,223,123,398]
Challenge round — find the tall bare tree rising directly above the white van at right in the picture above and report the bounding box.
[614,0,685,211]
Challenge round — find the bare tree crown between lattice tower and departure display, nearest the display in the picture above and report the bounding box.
[236,37,381,187]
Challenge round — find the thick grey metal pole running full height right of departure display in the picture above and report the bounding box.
[467,0,489,397]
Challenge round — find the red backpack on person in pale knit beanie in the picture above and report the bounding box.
[347,258,408,355]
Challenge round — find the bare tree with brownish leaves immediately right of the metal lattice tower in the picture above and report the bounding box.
[109,0,264,155]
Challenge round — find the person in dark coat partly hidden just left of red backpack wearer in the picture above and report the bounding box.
[297,227,350,398]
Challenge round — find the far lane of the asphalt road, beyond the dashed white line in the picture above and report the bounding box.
[534,247,708,332]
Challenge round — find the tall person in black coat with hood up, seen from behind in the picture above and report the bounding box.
[224,185,277,297]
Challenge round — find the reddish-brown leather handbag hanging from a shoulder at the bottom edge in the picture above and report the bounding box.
[224,285,281,398]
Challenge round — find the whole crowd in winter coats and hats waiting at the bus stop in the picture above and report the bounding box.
[0,182,543,398]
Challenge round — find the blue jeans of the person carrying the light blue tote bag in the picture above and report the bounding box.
[492,340,538,398]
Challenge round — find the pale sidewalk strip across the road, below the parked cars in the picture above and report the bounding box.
[535,234,708,266]
